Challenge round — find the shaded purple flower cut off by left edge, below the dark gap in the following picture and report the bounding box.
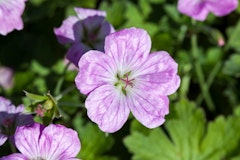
[0,97,33,146]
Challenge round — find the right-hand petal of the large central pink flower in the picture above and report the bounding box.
[135,51,180,95]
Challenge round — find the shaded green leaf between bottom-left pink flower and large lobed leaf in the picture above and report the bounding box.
[73,114,116,160]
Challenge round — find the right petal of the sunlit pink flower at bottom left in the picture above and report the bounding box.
[39,124,81,160]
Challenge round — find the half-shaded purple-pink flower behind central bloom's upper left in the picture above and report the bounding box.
[54,8,114,66]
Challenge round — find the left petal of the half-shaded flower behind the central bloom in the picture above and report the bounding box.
[54,16,79,44]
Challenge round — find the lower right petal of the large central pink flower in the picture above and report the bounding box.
[127,90,169,128]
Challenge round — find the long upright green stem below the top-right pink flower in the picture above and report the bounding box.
[191,21,215,111]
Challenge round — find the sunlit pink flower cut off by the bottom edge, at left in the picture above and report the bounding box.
[0,123,81,160]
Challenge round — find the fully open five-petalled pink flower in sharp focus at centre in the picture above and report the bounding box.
[75,28,180,132]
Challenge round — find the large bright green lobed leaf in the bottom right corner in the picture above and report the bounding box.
[124,100,240,160]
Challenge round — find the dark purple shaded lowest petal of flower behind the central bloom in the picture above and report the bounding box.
[66,42,90,67]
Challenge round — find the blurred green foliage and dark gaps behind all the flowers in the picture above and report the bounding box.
[0,0,240,160]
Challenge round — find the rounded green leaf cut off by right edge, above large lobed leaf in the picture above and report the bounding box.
[223,54,240,77]
